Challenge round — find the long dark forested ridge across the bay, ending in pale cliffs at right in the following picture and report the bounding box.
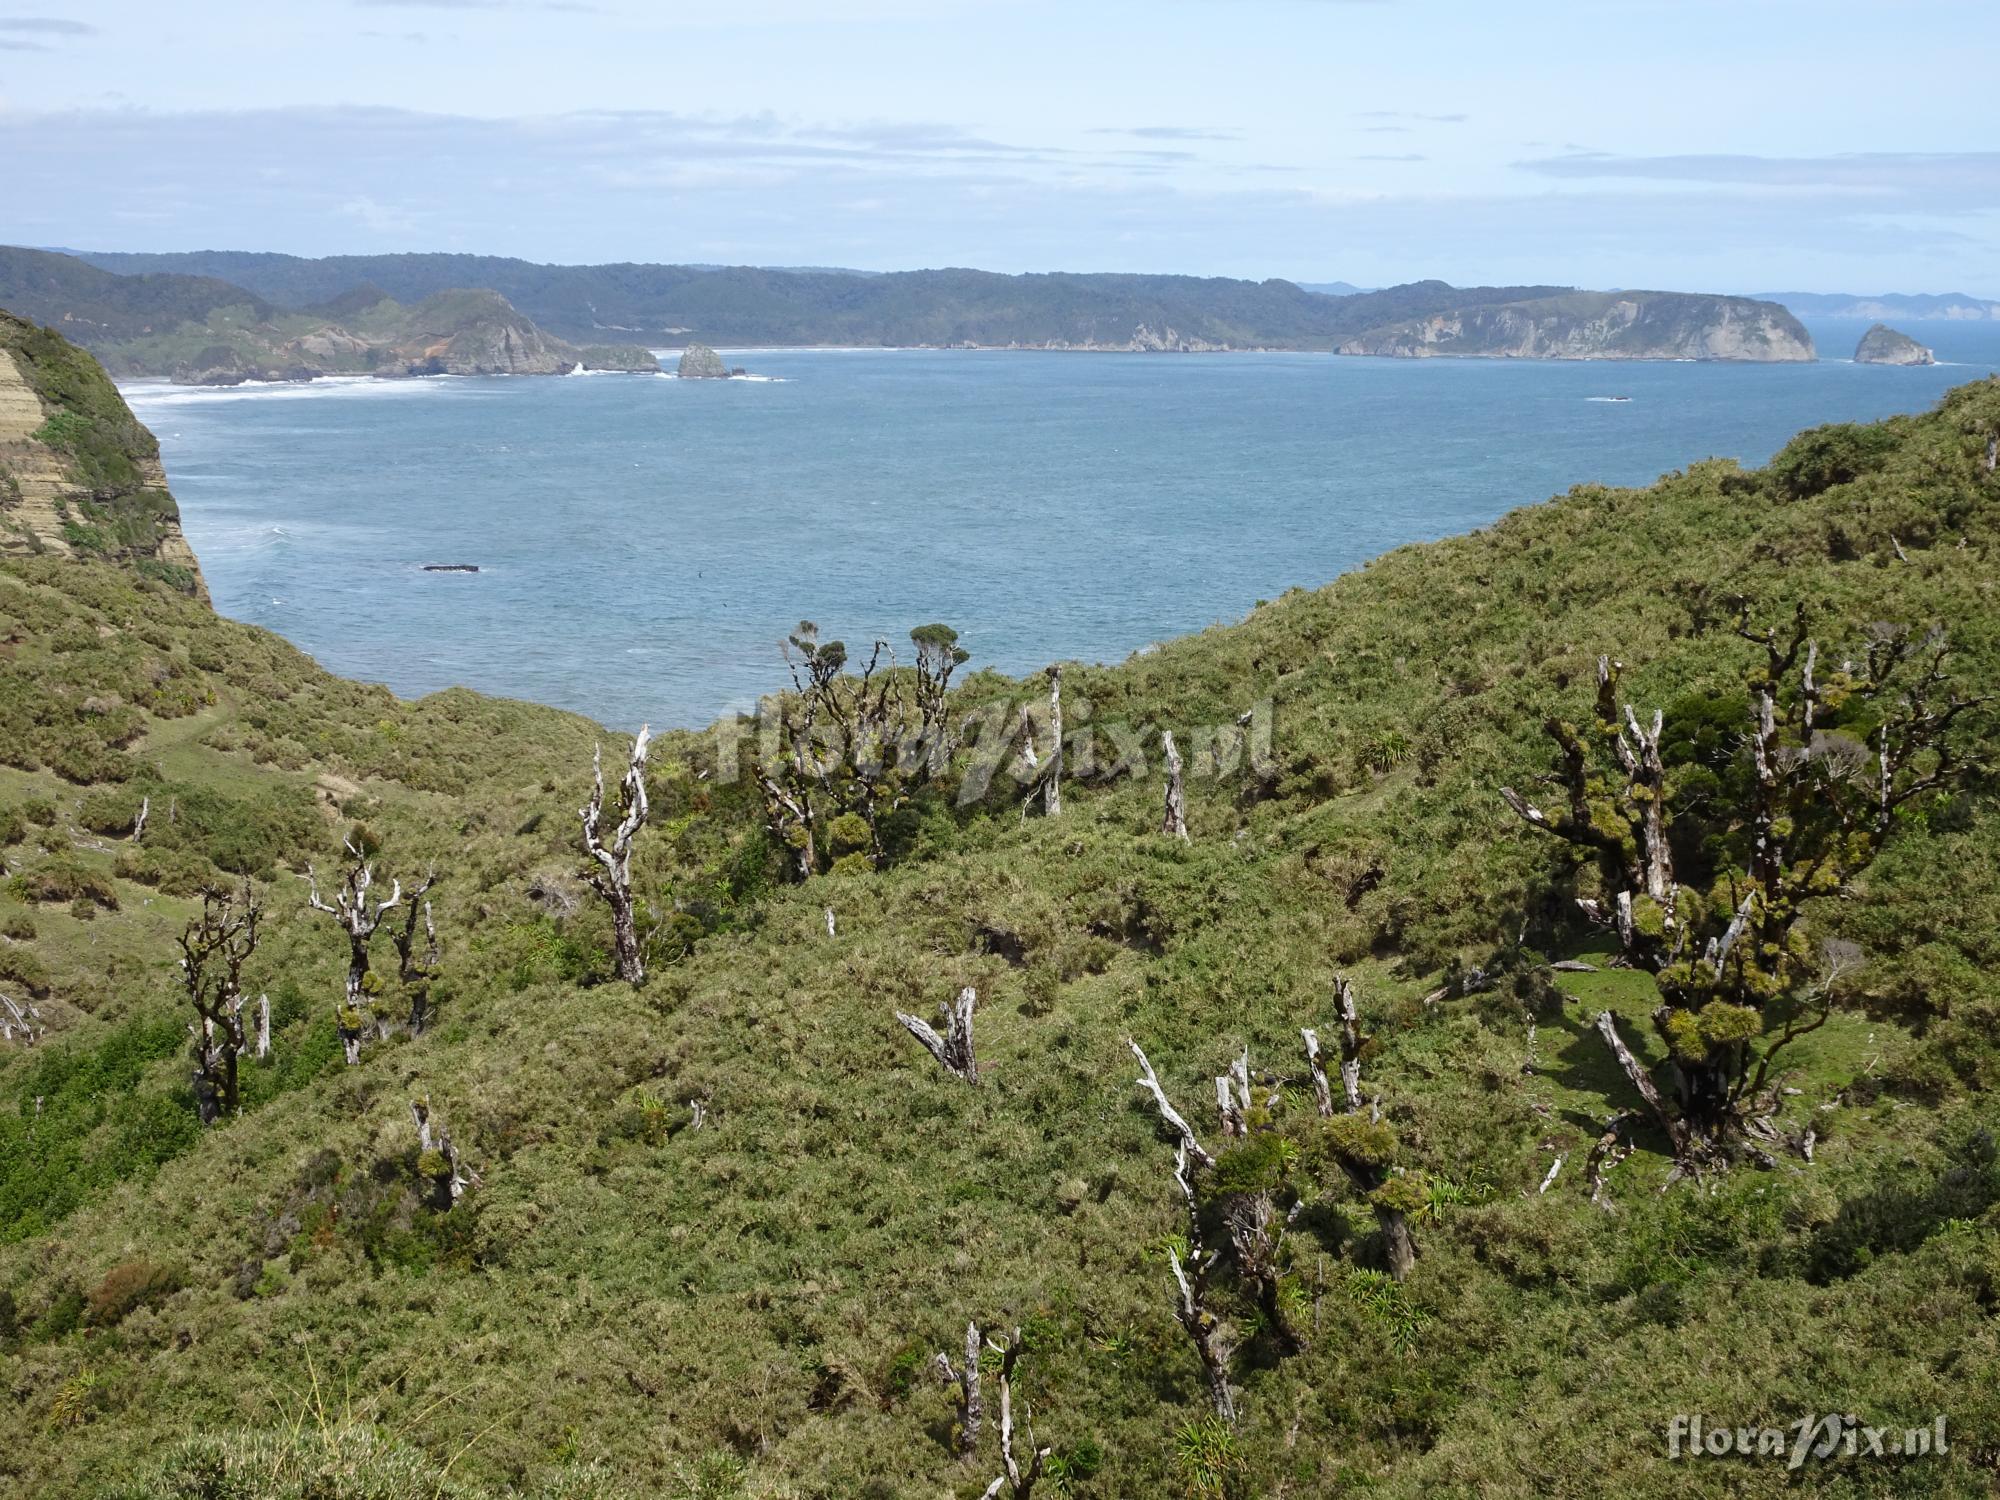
[58,250,1812,360]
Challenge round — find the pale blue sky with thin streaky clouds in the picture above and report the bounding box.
[0,0,2000,296]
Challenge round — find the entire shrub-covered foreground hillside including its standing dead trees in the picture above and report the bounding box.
[0,314,2000,1500]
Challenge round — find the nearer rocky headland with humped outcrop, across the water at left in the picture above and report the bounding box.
[0,248,660,386]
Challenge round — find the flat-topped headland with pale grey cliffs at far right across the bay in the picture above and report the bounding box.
[1336,292,1818,362]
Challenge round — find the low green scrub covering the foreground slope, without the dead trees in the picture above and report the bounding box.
[0,384,2000,1496]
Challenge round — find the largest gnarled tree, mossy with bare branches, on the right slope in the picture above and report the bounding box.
[1500,602,1986,1172]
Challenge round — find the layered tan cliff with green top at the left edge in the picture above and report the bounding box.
[0,312,208,600]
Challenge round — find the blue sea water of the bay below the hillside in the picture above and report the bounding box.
[128,320,2000,728]
